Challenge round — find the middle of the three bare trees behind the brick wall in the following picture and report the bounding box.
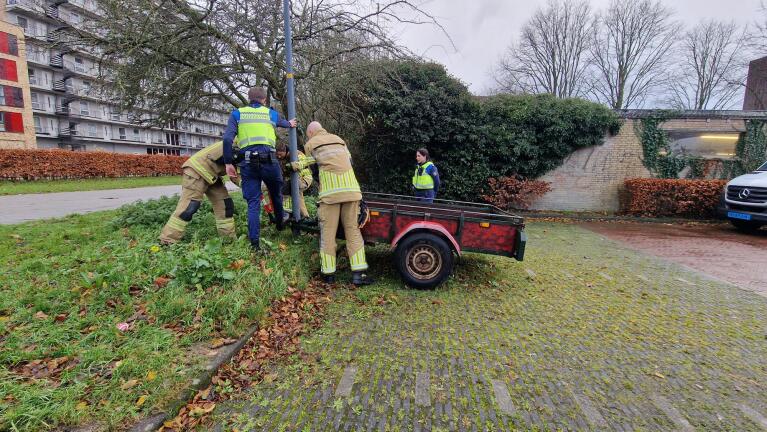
[591,0,679,109]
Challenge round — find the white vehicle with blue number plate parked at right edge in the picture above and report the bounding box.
[719,162,767,232]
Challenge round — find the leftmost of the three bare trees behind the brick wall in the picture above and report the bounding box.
[497,0,594,98]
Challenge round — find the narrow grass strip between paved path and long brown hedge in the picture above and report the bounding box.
[0,176,181,195]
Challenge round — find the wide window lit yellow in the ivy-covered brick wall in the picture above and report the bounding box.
[669,131,740,159]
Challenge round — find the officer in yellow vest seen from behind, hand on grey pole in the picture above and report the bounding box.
[224,87,296,251]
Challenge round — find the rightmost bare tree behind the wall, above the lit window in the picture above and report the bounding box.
[669,21,746,110]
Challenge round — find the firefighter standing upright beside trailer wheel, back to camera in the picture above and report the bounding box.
[291,122,373,285]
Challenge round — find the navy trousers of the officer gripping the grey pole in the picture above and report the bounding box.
[240,146,284,247]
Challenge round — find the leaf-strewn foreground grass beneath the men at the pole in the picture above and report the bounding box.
[0,194,316,431]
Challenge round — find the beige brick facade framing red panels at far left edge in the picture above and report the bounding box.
[0,19,37,149]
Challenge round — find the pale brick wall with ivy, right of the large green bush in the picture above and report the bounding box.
[532,119,745,212]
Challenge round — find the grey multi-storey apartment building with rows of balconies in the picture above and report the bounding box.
[4,0,228,155]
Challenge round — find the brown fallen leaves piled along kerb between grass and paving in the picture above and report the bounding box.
[160,282,330,432]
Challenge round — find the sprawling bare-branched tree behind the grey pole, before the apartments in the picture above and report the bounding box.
[68,0,450,124]
